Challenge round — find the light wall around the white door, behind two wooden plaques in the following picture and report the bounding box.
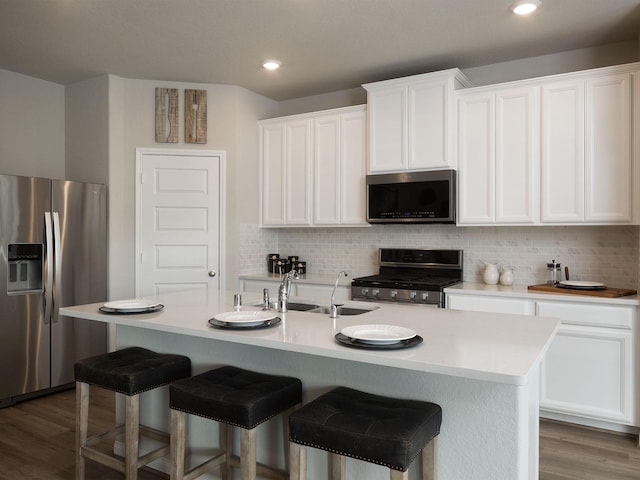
[108,76,277,299]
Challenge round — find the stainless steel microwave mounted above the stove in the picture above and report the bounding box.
[367,170,456,223]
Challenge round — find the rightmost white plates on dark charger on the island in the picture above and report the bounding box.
[335,324,422,349]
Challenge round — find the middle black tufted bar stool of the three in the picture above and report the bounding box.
[169,366,302,480]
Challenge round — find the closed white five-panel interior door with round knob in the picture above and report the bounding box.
[136,149,225,296]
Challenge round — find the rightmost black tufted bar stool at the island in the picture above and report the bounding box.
[289,387,442,480]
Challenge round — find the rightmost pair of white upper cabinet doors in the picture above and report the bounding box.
[541,67,640,224]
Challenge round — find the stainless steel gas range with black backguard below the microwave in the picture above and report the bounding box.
[351,248,462,308]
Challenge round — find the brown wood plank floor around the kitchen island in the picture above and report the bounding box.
[0,388,640,480]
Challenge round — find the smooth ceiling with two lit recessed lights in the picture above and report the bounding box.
[0,0,640,100]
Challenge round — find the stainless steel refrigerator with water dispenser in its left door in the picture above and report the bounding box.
[0,175,107,408]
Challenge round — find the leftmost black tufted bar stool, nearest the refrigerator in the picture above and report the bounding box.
[74,347,191,480]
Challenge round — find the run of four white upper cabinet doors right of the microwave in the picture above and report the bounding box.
[456,64,640,225]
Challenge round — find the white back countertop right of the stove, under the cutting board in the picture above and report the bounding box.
[444,282,640,305]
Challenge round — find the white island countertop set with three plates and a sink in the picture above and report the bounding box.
[60,291,559,385]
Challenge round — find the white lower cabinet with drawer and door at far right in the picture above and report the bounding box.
[536,302,636,425]
